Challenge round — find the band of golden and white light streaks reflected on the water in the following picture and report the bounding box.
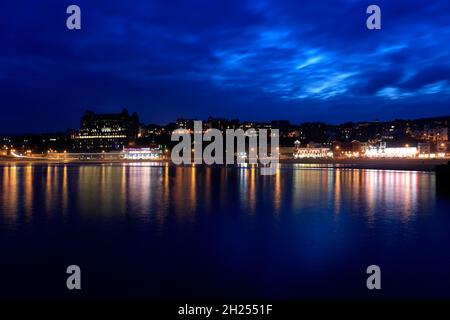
[0,164,436,228]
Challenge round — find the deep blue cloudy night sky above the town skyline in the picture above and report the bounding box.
[0,0,450,133]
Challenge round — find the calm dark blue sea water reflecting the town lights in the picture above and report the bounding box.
[0,163,450,299]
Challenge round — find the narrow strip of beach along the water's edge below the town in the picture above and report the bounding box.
[0,156,449,171]
